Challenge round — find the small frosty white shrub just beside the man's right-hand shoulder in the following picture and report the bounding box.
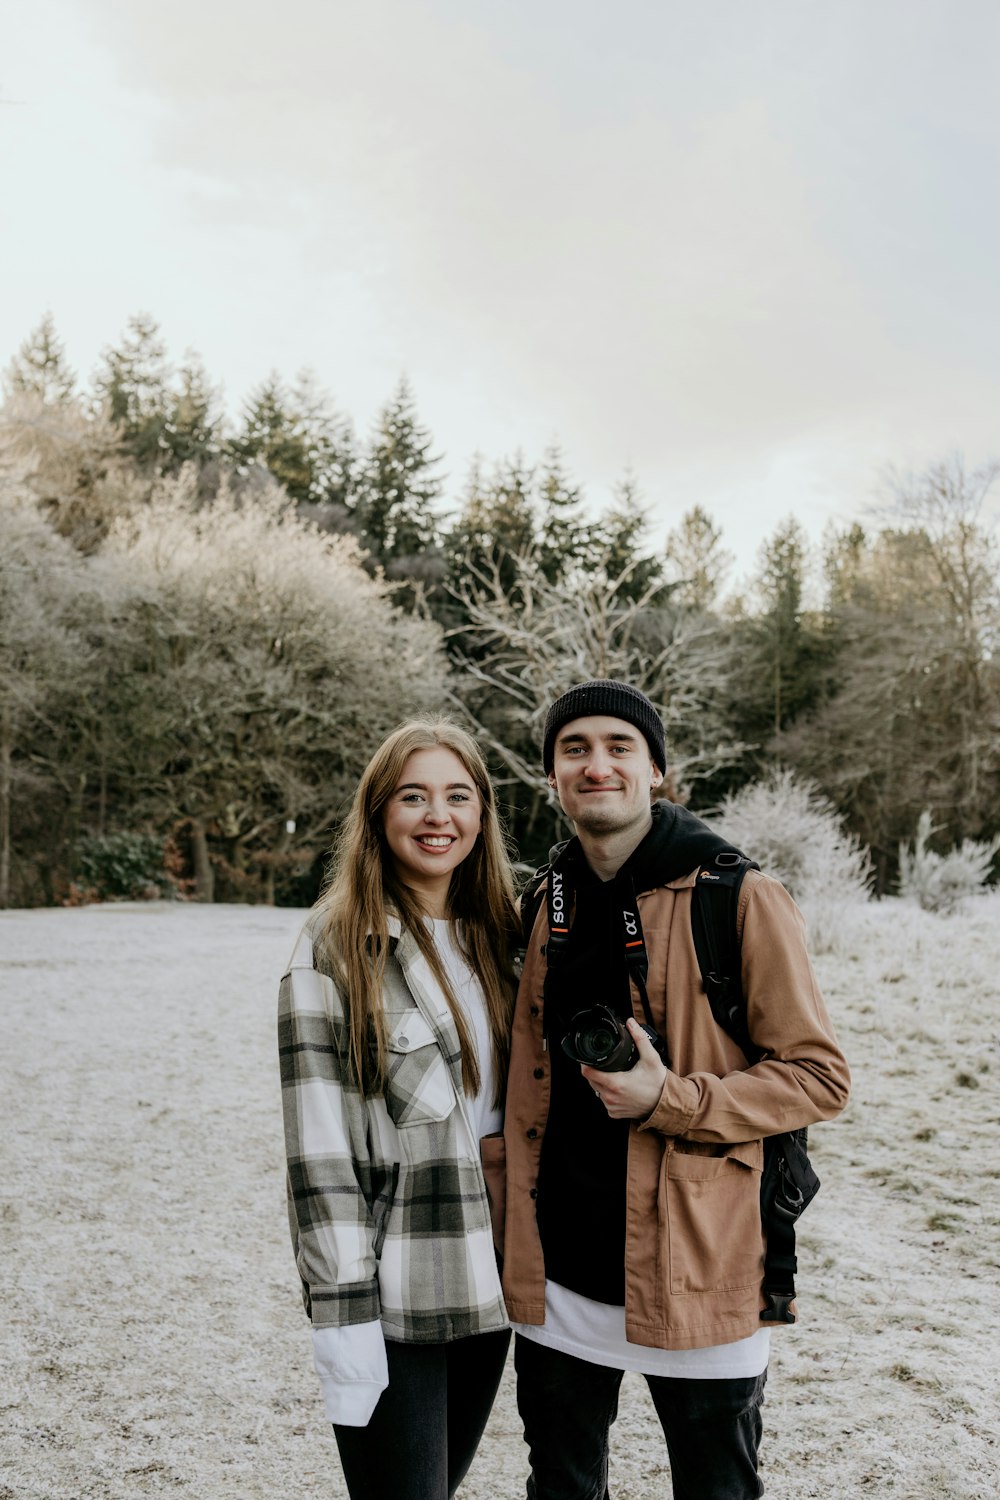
[712,768,871,953]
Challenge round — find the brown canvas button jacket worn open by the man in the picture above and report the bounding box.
[504,870,850,1349]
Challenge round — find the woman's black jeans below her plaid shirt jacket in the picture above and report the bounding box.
[333,1329,510,1500]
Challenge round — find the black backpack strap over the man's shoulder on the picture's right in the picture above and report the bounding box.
[691,849,760,1062]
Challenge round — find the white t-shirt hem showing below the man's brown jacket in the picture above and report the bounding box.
[514,1281,771,1380]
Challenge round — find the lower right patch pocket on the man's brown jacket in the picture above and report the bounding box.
[660,1140,763,1293]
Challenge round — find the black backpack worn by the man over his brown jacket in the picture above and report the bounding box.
[520,845,820,1323]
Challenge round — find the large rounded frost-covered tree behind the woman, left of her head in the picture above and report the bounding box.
[102,479,445,899]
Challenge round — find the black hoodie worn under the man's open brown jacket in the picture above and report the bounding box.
[537,803,733,1307]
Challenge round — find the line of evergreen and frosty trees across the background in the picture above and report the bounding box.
[0,315,1000,905]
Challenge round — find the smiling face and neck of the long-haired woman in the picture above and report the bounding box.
[382,746,483,917]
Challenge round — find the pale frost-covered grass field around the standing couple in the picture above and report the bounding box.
[0,896,1000,1500]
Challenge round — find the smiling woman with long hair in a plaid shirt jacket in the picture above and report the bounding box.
[279,722,516,1500]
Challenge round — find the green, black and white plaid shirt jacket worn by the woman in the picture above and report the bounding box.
[277,920,507,1344]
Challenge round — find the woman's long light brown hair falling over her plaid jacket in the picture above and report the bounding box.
[318,719,517,1106]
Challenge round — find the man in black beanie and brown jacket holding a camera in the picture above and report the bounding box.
[504,680,849,1500]
